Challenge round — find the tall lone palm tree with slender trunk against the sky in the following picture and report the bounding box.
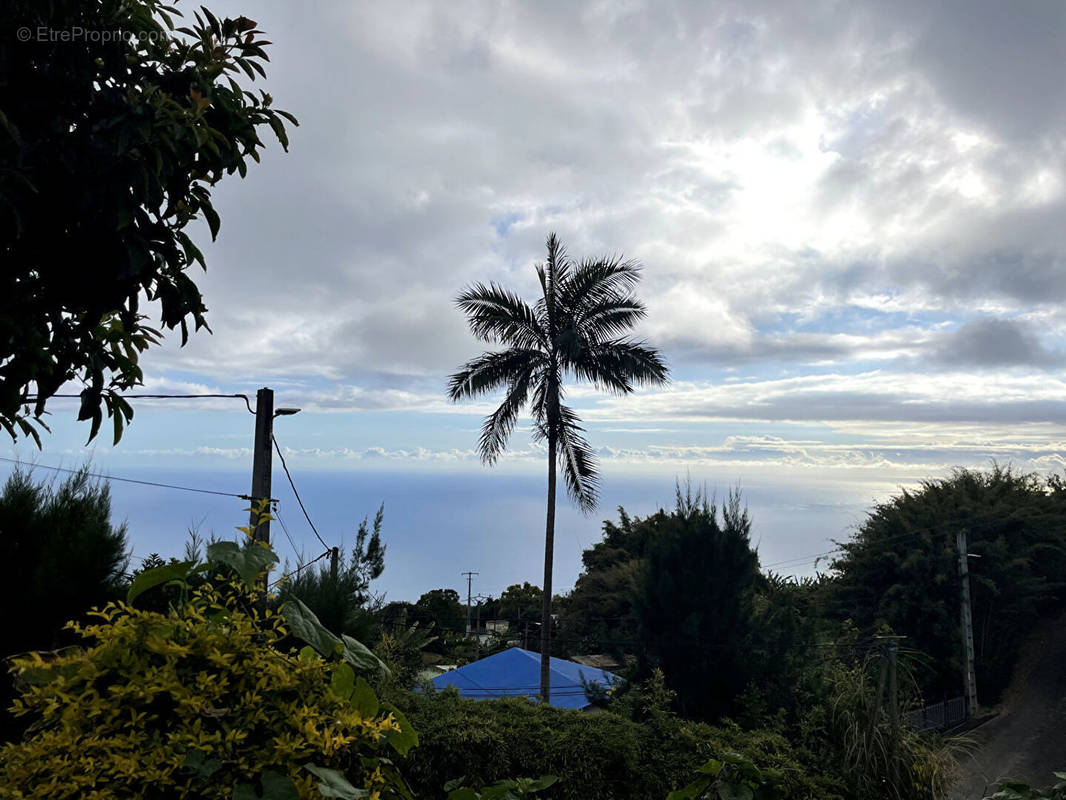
[448,234,667,701]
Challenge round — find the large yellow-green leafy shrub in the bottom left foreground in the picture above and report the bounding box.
[0,579,403,800]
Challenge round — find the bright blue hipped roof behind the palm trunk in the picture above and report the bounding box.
[432,647,623,709]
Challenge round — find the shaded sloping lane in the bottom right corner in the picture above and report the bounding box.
[951,615,1066,800]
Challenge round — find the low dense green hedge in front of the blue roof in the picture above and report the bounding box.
[400,691,839,800]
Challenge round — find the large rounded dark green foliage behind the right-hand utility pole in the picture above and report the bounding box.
[833,466,1066,702]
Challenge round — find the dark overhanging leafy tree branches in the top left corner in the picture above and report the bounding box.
[0,0,295,444]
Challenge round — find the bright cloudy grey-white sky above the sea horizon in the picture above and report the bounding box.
[83,0,1066,482]
